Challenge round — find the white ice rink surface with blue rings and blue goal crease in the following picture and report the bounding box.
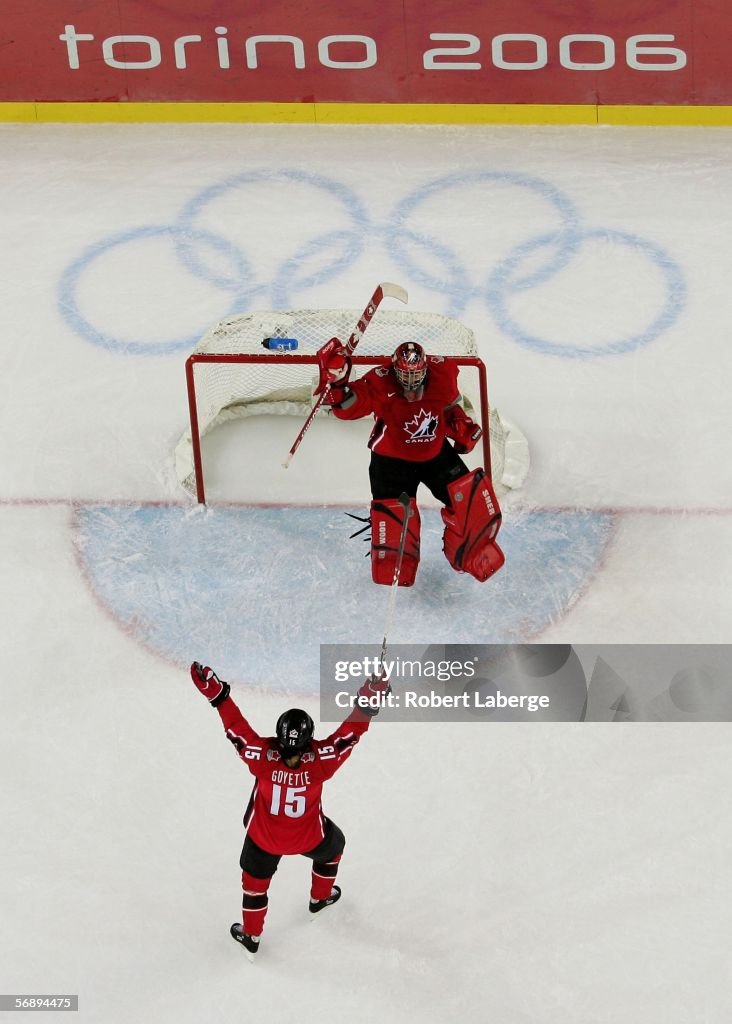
[0,125,732,1024]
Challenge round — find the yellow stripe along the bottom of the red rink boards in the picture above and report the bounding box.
[0,102,732,127]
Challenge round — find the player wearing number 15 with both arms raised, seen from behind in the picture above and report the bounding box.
[190,662,390,959]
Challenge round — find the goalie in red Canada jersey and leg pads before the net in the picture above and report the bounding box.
[316,338,504,587]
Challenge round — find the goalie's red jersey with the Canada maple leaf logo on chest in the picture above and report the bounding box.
[333,355,460,462]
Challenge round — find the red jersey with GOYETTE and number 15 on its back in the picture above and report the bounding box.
[217,697,371,854]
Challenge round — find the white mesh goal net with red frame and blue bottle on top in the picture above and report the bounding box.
[175,307,528,501]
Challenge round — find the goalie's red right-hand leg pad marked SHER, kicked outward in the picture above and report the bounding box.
[442,469,505,583]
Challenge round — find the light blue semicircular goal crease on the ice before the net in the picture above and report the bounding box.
[75,506,613,694]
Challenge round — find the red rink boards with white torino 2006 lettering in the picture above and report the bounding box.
[0,0,732,104]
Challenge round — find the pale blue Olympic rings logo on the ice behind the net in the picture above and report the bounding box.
[58,168,686,358]
